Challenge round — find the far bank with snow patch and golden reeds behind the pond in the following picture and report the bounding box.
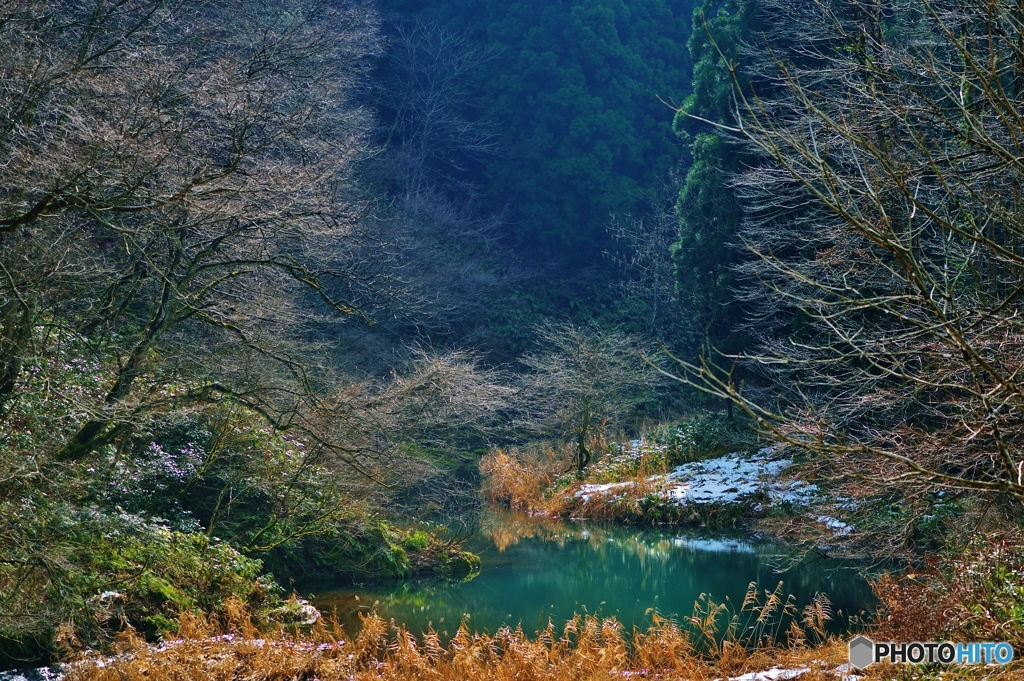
[480,428,839,537]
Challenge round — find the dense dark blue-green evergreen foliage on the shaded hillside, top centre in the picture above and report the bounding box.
[382,0,690,258]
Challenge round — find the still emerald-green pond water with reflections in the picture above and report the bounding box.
[313,512,871,636]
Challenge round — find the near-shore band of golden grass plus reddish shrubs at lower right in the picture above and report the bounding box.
[25,541,1024,681]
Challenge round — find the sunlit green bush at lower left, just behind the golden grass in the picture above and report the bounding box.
[0,516,268,657]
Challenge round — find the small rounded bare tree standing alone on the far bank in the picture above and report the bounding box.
[520,322,651,471]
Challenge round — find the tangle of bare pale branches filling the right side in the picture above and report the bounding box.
[663,0,1024,540]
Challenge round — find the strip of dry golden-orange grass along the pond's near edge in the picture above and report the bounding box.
[59,604,838,681]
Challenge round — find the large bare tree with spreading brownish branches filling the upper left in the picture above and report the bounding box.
[0,0,394,461]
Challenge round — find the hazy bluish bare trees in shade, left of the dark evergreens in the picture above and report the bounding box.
[336,19,527,371]
